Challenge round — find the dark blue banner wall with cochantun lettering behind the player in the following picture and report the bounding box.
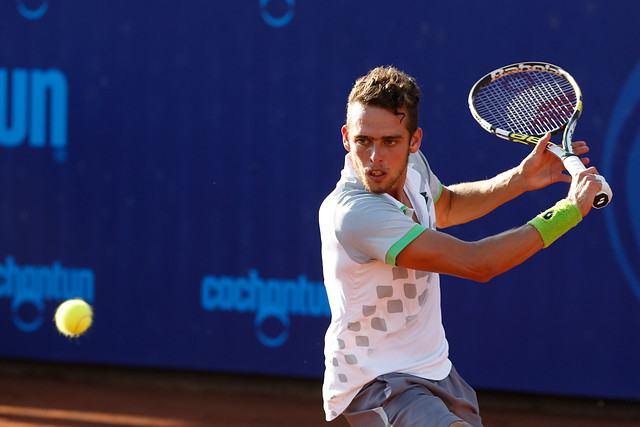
[0,0,640,414]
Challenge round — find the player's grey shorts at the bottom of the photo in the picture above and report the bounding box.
[343,368,482,427]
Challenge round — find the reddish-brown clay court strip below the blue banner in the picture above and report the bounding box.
[0,361,640,427]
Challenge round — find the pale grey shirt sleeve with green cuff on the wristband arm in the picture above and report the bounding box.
[335,191,426,265]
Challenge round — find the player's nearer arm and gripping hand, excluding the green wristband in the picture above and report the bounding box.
[395,168,601,282]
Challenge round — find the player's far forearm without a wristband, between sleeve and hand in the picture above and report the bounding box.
[436,167,525,228]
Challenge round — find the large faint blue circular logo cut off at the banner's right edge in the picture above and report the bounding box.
[603,62,640,299]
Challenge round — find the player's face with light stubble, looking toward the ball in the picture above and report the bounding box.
[342,103,422,199]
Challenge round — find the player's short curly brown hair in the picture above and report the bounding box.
[347,66,420,135]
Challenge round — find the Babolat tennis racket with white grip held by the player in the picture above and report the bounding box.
[469,62,613,209]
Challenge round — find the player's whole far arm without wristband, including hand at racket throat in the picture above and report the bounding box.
[435,135,589,228]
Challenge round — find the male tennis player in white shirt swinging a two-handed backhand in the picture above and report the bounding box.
[320,67,601,427]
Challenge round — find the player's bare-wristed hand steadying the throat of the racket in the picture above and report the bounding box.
[520,133,589,191]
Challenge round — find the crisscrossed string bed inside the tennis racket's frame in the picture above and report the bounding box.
[474,71,577,135]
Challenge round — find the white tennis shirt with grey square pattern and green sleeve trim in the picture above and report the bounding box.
[319,151,451,421]
